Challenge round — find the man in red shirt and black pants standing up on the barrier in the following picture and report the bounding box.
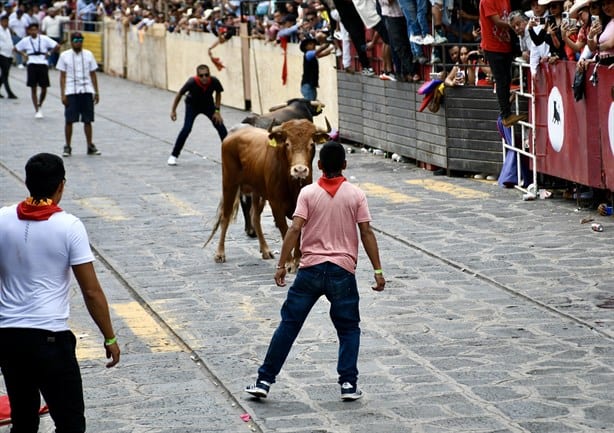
[480,0,527,127]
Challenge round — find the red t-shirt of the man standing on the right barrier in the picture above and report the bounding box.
[480,0,512,53]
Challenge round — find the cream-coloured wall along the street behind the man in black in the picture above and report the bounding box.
[104,20,339,127]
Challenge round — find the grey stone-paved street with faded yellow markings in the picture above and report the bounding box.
[0,71,614,433]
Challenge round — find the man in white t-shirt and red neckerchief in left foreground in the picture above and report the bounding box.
[0,153,120,433]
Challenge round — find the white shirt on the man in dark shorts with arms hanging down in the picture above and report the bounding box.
[56,49,98,95]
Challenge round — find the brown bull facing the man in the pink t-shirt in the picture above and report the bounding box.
[205,119,328,270]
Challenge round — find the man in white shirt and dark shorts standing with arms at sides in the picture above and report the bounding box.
[57,32,100,157]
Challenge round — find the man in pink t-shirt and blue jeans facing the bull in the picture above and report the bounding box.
[245,141,386,401]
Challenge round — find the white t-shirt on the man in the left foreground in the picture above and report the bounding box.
[0,205,94,332]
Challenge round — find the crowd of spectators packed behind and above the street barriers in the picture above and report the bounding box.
[0,0,614,86]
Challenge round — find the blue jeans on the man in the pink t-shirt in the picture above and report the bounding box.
[258,262,360,384]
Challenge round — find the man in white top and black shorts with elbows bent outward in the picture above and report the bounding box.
[15,22,60,119]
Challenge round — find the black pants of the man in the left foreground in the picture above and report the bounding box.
[0,328,85,433]
